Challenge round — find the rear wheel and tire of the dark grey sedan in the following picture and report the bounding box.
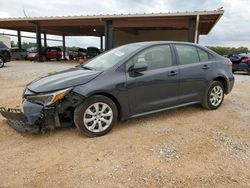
[202,81,225,110]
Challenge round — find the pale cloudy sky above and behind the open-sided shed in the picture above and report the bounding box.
[0,0,250,48]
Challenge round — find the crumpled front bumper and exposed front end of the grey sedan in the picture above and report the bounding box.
[0,89,83,133]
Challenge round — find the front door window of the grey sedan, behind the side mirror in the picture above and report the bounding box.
[126,45,172,70]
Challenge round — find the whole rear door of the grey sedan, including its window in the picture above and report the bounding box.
[174,44,213,104]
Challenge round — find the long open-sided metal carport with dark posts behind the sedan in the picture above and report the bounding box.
[0,10,224,61]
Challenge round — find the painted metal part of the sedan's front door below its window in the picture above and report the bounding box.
[127,66,179,115]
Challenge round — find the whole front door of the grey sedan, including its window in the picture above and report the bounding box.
[126,45,179,115]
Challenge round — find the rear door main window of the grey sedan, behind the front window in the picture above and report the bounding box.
[175,44,200,65]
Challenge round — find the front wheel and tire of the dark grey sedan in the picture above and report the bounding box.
[74,95,118,137]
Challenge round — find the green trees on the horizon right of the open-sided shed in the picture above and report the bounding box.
[207,46,250,55]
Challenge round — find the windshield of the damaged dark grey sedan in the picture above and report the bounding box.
[83,44,141,70]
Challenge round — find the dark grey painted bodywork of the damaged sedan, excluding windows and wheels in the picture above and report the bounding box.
[1,41,234,133]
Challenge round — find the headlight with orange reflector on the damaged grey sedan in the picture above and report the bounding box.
[26,88,71,106]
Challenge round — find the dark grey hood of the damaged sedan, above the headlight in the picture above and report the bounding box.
[27,67,101,93]
